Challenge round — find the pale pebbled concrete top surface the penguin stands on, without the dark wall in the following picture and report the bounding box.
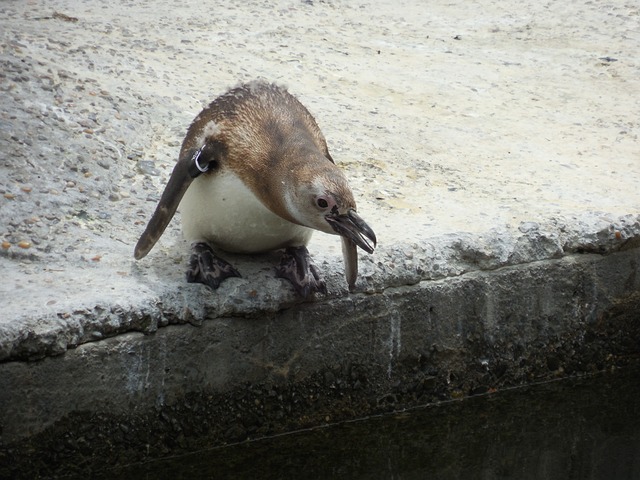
[0,0,640,474]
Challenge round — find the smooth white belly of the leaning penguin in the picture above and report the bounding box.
[180,172,313,253]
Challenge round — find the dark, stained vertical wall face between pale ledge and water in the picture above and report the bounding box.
[0,249,640,473]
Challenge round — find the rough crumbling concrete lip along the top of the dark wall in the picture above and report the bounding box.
[0,212,640,362]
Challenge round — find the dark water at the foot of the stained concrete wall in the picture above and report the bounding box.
[81,364,640,480]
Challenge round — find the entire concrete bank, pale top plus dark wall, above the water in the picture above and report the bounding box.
[0,0,640,478]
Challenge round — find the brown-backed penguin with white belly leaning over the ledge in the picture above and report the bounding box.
[134,80,377,298]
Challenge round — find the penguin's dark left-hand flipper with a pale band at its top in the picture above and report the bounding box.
[134,143,218,260]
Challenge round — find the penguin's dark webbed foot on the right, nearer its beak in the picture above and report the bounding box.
[276,246,327,298]
